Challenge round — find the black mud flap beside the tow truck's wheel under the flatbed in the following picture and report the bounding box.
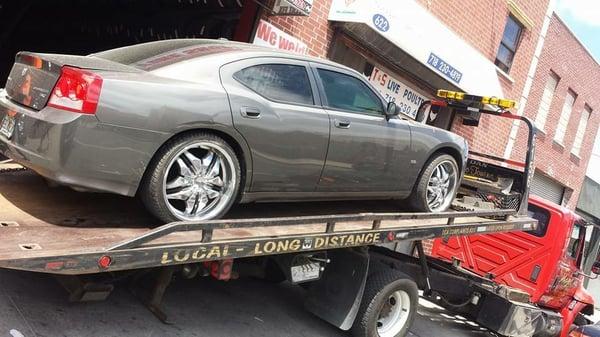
[304,245,369,330]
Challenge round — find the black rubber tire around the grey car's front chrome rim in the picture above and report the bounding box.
[408,153,460,212]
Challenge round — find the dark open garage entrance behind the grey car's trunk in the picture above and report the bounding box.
[0,0,257,81]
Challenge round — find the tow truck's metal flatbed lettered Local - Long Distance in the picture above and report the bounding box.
[0,172,536,275]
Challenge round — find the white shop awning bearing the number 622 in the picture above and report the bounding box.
[329,0,504,97]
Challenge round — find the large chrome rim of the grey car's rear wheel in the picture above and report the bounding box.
[163,141,237,220]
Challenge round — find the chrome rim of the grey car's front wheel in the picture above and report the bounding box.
[427,160,457,212]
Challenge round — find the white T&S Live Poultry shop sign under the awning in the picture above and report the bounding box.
[369,67,427,119]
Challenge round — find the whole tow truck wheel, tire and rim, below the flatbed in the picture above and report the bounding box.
[352,269,419,337]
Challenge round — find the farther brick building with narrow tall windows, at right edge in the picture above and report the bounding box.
[512,14,600,209]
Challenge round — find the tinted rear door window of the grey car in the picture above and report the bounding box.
[233,64,315,105]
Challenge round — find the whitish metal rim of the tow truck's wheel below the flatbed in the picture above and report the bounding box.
[377,290,410,337]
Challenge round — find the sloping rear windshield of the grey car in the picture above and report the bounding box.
[90,39,241,71]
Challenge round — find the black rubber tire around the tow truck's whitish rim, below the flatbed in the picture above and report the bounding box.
[351,268,419,337]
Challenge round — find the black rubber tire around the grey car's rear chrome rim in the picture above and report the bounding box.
[138,131,242,223]
